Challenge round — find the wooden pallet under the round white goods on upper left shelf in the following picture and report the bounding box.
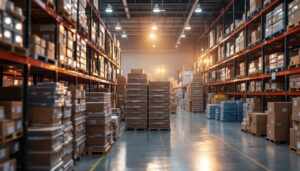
[0,40,29,57]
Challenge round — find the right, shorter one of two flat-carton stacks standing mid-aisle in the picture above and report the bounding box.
[148,81,170,130]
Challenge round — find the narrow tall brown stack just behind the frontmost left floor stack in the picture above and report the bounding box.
[68,86,86,161]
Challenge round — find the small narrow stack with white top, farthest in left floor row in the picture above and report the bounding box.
[111,108,121,141]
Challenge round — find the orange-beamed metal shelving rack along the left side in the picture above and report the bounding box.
[0,0,121,170]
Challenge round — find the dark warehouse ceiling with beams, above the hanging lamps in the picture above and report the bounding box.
[100,0,230,45]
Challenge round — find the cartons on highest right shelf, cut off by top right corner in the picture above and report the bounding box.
[288,0,300,29]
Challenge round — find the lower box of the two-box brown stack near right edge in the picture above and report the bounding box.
[267,124,289,142]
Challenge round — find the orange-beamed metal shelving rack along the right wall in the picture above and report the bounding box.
[196,0,300,109]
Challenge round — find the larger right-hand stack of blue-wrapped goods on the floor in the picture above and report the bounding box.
[220,101,236,122]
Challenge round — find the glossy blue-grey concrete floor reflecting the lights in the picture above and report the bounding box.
[75,109,300,171]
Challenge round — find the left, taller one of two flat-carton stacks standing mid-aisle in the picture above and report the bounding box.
[125,69,149,130]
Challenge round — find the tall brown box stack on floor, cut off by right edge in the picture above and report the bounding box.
[290,97,300,154]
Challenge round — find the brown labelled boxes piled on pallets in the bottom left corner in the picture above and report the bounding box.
[0,88,23,170]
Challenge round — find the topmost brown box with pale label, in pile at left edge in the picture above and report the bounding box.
[0,101,23,119]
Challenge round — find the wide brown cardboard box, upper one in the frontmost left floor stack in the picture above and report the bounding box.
[29,106,62,125]
